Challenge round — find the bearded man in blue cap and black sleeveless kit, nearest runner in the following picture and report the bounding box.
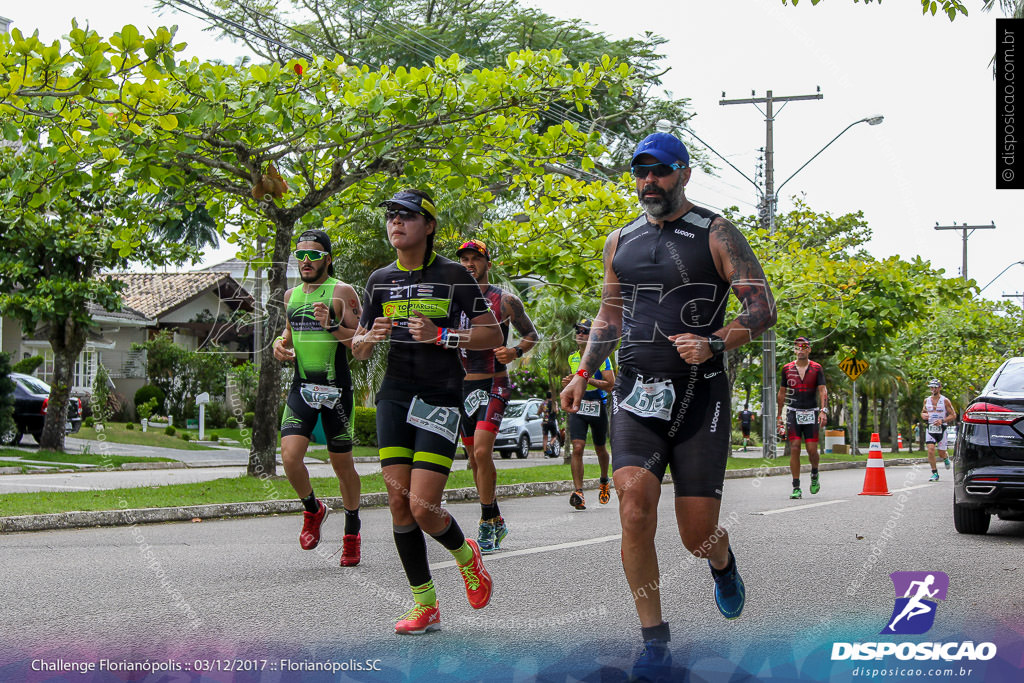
[562,133,775,680]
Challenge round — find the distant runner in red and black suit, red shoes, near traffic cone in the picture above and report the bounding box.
[778,337,828,499]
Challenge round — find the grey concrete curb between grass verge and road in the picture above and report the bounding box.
[0,458,927,533]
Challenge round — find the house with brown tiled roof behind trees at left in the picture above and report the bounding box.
[0,270,255,400]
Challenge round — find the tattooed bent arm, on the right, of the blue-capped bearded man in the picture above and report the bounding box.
[669,216,775,364]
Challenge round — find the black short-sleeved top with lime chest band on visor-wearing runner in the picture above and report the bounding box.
[359,253,488,404]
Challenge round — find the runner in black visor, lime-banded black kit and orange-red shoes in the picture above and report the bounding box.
[352,189,501,634]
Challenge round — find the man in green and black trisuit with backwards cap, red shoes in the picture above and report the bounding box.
[273,230,361,566]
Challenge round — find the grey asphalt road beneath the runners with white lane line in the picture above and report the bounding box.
[0,467,1024,681]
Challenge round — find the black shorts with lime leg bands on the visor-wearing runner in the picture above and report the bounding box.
[377,398,459,475]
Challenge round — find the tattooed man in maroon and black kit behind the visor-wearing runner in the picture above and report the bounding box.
[456,240,540,554]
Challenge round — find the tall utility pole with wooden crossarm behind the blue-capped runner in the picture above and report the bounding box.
[718,86,824,458]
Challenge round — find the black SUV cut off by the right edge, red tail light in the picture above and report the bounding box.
[953,357,1024,533]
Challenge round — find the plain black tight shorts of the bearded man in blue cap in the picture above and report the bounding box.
[611,369,731,500]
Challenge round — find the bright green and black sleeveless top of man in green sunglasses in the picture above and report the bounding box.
[287,278,352,387]
